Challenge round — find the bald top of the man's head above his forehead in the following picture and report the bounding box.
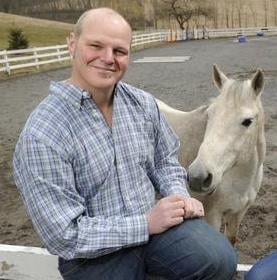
[74,8,132,37]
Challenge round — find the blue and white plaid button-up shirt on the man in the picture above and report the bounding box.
[14,82,189,259]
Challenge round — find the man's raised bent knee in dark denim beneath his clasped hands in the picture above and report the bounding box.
[146,219,236,280]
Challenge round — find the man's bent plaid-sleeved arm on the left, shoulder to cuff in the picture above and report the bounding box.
[14,136,149,259]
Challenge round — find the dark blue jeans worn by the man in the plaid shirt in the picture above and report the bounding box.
[59,219,237,280]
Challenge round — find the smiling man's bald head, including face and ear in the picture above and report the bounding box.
[69,8,132,90]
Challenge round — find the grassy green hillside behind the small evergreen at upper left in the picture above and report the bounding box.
[0,13,72,49]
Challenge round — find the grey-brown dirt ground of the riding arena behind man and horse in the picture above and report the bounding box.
[0,37,277,270]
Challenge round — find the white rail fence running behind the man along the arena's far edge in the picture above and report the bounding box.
[0,27,277,75]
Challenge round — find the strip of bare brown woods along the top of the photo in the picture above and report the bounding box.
[0,0,277,30]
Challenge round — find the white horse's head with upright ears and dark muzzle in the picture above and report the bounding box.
[188,65,264,194]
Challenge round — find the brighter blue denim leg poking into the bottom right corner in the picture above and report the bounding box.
[244,252,277,280]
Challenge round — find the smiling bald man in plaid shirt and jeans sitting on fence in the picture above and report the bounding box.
[14,8,236,280]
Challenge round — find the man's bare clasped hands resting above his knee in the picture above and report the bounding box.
[146,195,204,234]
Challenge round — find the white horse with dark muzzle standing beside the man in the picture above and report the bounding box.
[156,66,265,244]
